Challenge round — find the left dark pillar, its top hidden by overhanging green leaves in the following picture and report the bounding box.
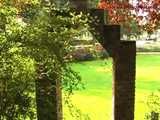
[36,65,62,120]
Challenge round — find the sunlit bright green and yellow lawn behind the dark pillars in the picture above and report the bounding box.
[64,55,160,120]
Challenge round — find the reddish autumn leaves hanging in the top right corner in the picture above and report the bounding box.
[98,0,160,33]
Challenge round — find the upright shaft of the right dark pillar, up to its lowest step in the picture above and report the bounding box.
[113,41,136,120]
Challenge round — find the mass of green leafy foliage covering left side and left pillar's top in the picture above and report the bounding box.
[0,1,88,120]
